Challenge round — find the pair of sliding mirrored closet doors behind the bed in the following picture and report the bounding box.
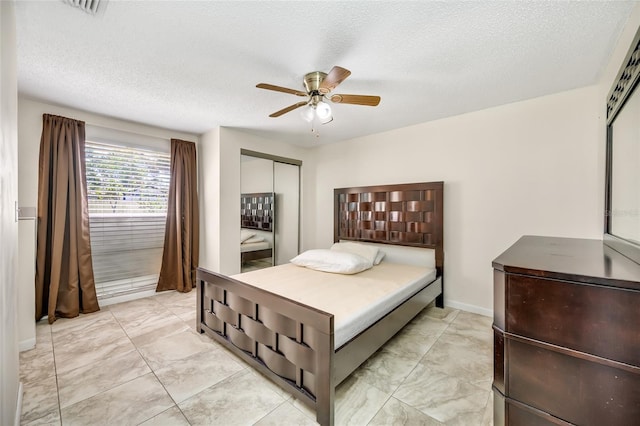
[240,150,302,272]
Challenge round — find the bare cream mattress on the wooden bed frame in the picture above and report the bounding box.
[233,262,436,349]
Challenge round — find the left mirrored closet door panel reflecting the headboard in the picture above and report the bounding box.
[240,155,275,272]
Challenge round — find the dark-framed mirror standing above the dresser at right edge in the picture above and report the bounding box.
[604,26,640,262]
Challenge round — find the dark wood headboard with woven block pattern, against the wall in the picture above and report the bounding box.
[333,182,444,275]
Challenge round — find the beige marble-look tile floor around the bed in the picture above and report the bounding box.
[20,291,493,426]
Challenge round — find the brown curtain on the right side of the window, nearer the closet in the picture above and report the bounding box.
[156,139,199,293]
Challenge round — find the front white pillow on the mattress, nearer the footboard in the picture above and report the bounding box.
[290,249,373,274]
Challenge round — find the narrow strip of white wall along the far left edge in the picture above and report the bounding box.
[0,1,22,425]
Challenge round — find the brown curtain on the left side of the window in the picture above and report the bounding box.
[36,114,100,324]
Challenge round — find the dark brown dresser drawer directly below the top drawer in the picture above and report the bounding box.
[505,336,640,426]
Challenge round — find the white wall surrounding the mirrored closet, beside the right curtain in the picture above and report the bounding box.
[200,127,312,275]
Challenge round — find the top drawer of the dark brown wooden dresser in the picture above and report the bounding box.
[505,274,640,366]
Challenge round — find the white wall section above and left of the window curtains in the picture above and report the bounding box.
[18,97,199,207]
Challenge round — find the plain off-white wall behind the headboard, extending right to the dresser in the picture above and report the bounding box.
[314,86,603,314]
